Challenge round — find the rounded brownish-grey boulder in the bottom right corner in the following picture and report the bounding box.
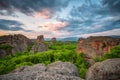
[85,58,120,80]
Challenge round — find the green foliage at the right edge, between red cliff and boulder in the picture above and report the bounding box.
[94,46,120,62]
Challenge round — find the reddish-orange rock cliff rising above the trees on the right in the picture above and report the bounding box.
[77,36,120,58]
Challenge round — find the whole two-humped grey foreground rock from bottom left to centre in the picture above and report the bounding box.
[0,61,83,80]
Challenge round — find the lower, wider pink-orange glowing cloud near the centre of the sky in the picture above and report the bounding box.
[42,22,68,31]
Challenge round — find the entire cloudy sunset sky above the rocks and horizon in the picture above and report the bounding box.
[0,0,120,38]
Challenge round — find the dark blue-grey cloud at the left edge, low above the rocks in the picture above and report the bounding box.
[0,19,29,31]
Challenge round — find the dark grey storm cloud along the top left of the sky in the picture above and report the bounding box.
[0,0,69,15]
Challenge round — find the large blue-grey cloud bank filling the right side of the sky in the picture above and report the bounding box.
[58,0,120,35]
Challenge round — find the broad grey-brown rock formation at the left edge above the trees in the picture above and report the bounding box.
[0,34,32,57]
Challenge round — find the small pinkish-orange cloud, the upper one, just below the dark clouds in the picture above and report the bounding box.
[34,9,51,19]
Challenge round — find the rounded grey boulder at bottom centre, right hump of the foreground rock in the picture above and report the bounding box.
[47,62,79,77]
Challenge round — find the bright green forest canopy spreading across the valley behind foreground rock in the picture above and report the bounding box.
[0,42,88,78]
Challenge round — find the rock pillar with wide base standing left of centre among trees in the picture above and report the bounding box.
[30,35,48,53]
